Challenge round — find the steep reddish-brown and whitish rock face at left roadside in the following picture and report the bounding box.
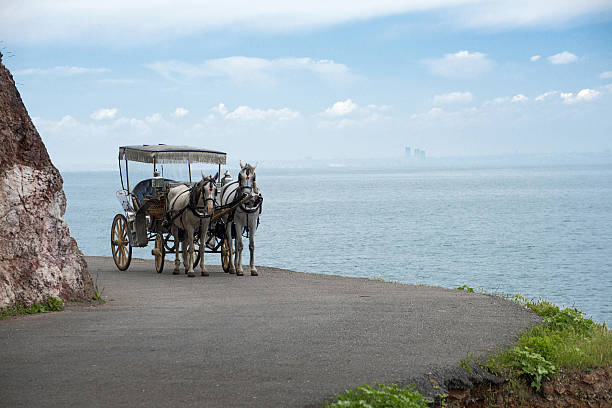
[0,54,94,308]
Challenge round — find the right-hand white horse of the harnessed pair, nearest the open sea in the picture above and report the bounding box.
[220,160,263,276]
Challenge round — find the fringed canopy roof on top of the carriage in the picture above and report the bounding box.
[119,144,227,164]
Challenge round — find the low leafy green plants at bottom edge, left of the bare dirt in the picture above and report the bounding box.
[325,383,431,408]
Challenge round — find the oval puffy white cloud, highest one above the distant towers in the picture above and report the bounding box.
[423,51,493,78]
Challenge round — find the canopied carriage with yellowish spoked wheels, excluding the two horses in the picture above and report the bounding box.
[111,144,235,273]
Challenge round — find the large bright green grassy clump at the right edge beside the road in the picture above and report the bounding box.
[483,295,612,390]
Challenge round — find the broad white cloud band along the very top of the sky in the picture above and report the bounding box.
[0,0,612,44]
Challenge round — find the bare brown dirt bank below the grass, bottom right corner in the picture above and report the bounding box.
[447,367,612,408]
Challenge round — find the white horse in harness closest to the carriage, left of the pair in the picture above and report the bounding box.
[166,173,218,278]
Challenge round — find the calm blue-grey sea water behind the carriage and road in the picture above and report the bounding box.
[63,166,612,322]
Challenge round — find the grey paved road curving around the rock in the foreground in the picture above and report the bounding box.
[0,257,536,407]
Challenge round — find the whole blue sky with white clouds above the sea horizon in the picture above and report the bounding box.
[0,0,612,170]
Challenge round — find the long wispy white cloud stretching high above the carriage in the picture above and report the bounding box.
[146,56,354,84]
